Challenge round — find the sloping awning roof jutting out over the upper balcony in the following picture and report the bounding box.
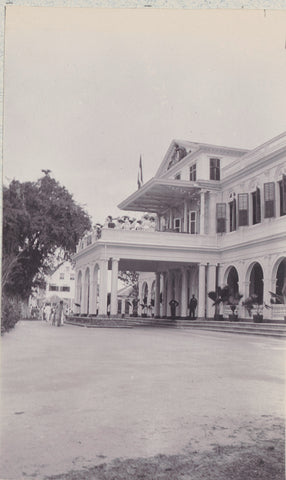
[118,177,202,213]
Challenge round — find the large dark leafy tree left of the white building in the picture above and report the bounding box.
[2,171,91,299]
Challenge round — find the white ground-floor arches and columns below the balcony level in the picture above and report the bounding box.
[75,257,286,318]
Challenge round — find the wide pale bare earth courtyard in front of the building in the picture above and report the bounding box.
[0,322,285,480]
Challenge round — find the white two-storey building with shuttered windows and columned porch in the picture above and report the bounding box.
[74,133,286,320]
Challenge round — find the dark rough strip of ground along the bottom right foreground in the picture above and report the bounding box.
[46,440,285,480]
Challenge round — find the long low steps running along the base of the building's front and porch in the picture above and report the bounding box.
[65,317,286,338]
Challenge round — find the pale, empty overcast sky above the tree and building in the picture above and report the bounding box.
[3,5,286,223]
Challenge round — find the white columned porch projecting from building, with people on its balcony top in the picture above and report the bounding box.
[75,231,218,318]
